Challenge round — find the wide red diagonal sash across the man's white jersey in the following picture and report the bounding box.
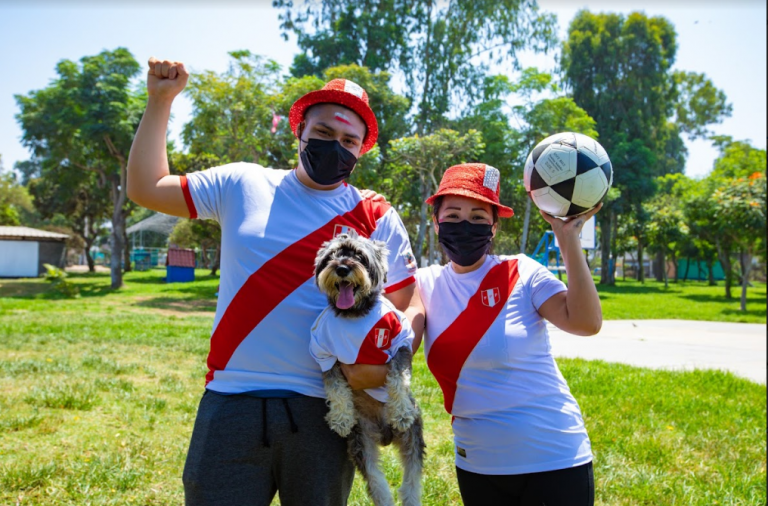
[205,199,389,383]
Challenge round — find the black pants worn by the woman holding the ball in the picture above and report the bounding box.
[456,462,595,506]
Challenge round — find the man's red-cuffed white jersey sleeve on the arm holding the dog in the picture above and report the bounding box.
[371,208,416,293]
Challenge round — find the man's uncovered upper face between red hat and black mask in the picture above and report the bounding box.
[299,104,367,158]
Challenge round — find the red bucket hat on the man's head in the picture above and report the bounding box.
[288,79,379,155]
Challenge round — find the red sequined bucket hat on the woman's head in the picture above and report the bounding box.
[427,163,515,218]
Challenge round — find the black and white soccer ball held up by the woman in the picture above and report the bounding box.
[523,132,613,218]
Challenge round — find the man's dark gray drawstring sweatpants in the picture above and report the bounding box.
[183,390,355,506]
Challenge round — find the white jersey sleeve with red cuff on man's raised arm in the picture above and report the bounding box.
[181,163,242,222]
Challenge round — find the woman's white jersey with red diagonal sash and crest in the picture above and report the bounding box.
[416,255,592,474]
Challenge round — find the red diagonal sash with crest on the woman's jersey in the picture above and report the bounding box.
[427,260,520,413]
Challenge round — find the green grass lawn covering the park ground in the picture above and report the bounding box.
[0,270,766,506]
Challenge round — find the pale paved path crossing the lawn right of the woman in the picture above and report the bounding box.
[549,320,768,384]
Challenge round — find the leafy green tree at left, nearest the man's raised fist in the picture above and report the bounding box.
[15,48,145,289]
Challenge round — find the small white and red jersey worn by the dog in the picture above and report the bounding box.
[309,297,413,402]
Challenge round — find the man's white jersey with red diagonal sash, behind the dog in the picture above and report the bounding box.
[181,163,416,397]
